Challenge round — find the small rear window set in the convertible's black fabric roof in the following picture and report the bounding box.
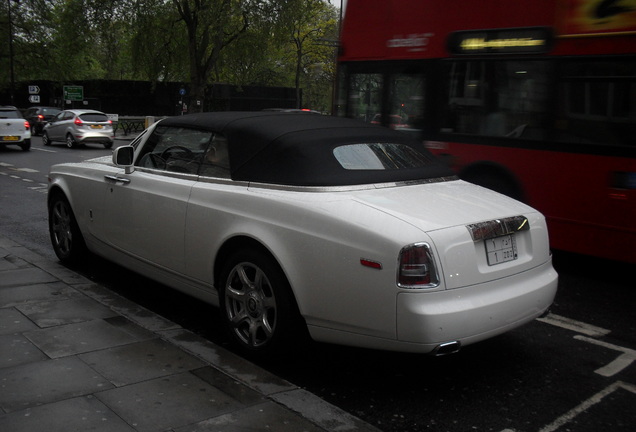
[333,143,438,170]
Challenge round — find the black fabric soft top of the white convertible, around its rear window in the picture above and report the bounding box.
[161,111,453,186]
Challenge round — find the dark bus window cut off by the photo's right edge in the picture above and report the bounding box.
[555,59,636,146]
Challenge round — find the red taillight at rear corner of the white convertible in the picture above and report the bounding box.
[397,243,439,289]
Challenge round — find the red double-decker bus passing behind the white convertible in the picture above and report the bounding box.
[334,0,636,262]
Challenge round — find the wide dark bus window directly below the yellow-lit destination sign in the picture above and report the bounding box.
[442,60,549,139]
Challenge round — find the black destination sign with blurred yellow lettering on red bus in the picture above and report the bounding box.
[448,27,553,55]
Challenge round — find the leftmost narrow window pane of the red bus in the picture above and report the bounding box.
[349,73,382,123]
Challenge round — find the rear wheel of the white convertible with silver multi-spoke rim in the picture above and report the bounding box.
[219,249,306,357]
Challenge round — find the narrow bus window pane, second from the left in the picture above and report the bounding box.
[386,74,425,132]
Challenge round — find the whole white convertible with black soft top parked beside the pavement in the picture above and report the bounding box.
[48,112,557,354]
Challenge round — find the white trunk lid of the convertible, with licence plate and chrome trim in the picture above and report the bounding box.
[358,181,549,289]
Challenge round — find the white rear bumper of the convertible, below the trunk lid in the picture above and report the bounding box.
[397,260,558,352]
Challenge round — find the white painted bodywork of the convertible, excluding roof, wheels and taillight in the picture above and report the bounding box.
[50,113,558,352]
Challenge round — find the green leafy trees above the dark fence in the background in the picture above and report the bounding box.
[0,0,338,110]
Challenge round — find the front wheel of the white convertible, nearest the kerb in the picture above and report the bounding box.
[49,192,87,263]
